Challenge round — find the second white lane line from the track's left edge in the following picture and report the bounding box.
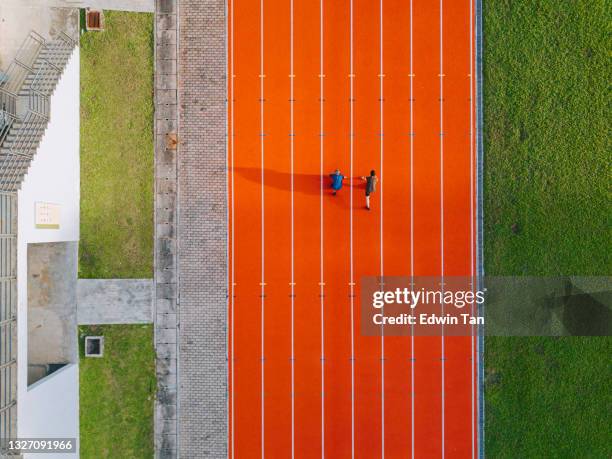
[259,0,266,459]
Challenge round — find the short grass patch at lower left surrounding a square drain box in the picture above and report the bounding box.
[79,325,156,459]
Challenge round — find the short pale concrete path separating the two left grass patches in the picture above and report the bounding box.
[77,279,153,325]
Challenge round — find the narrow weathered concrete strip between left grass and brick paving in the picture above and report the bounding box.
[154,0,179,458]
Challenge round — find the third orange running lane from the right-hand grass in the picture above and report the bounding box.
[379,0,412,457]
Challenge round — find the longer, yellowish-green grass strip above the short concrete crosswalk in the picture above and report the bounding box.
[79,11,153,278]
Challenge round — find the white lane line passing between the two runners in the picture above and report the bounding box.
[349,0,355,459]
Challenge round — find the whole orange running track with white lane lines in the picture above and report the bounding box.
[228,0,480,459]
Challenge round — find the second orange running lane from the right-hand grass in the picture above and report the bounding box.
[412,0,444,458]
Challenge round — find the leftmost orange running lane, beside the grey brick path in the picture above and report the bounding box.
[229,2,263,457]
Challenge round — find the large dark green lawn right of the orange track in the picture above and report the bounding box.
[484,0,612,458]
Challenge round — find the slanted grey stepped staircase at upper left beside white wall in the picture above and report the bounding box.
[0,32,76,193]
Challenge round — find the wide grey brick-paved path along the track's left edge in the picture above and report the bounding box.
[178,0,227,458]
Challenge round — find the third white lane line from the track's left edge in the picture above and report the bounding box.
[289,0,295,458]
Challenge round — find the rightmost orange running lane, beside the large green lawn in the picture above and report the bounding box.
[442,1,476,457]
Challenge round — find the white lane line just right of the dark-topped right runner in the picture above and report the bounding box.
[378,0,385,459]
